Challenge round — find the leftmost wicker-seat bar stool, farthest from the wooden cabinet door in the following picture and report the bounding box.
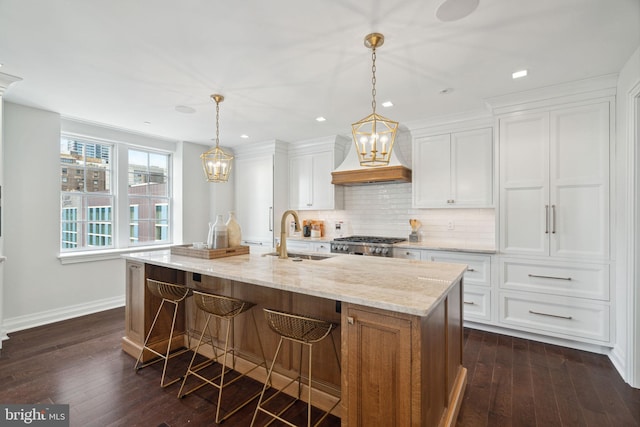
[134,279,191,387]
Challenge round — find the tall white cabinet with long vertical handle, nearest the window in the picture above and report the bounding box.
[233,141,288,247]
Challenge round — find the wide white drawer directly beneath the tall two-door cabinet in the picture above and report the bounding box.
[500,259,609,301]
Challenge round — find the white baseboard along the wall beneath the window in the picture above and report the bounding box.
[0,295,124,336]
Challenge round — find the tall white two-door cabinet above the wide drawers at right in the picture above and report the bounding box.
[499,101,610,259]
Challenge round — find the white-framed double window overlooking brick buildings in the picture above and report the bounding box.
[60,136,171,252]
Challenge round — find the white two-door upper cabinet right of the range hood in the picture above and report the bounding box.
[412,128,493,208]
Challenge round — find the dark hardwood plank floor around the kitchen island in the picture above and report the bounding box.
[0,309,640,427]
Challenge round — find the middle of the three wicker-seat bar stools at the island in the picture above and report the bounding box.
[178,291,267,424]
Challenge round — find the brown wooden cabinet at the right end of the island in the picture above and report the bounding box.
[342,284,466,426]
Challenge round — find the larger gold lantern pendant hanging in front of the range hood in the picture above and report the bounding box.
[351,33,398,166]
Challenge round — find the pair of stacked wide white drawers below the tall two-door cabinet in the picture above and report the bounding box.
[498,258,611,345]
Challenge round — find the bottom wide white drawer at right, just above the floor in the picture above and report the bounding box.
[500,292,609,342]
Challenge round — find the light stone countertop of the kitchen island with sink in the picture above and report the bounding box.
[123,250,467,316]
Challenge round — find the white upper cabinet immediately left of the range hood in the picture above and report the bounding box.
[289,136,349,210]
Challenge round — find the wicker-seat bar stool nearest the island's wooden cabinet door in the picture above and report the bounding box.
[251,308,340,427]
